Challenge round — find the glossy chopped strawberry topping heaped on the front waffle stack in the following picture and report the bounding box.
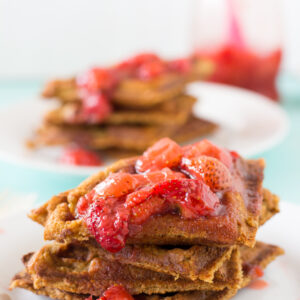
[77,138,241,252]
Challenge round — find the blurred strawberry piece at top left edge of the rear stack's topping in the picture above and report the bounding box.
[77,68,117,93]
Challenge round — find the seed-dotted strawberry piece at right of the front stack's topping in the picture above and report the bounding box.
[181,155,232,192]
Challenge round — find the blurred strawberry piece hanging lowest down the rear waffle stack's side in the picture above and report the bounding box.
[82,93,112,123]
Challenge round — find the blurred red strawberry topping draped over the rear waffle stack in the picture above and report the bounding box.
[76,53,191,124]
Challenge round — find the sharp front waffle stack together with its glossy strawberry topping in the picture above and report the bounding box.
[11,138,283,300]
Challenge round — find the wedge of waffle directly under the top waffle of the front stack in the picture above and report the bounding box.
[67,241,234,283]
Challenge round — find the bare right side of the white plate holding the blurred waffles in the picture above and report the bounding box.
[188,83,289,157]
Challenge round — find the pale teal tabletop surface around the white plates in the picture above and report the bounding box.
[0,75,300,204]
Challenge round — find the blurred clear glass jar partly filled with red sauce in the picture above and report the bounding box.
[193,0,282,100]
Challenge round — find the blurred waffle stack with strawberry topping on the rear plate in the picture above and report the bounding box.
[31,54,216,163]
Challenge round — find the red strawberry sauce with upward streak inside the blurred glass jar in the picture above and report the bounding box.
[195,0,282,100]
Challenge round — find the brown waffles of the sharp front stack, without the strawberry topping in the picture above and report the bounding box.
[11,138,283,300]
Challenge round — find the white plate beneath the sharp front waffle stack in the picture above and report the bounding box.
[0,202,300,300]
